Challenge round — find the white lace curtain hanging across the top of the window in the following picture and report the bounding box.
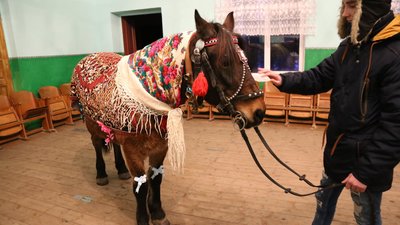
[215,0,316,35]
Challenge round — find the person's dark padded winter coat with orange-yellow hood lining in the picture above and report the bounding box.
[279,13,400,191]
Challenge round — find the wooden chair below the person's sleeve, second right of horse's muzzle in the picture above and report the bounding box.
[288,94,316,128]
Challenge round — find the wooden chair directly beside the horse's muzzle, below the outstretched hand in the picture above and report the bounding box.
[264,82,288,123]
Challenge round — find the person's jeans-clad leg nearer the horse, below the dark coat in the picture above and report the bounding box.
[312,173,343,225]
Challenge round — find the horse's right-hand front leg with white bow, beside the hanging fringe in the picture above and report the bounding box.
[147,140,170,225]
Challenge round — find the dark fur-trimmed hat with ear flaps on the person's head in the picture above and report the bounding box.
[338,0,392,44]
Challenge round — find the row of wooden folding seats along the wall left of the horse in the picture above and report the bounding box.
[0,83,81,144]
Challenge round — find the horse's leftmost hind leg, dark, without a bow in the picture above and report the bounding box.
[92,134,108,186]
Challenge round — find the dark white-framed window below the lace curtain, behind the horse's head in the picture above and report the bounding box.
[242,35,304,73]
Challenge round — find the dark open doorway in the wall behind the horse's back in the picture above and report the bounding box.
[121,13,163,55]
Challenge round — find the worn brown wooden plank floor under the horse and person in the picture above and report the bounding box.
[0,119,400,225]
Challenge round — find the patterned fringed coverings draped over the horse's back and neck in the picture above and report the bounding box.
[71,32,197,171]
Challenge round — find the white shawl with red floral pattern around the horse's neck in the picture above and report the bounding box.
[128,33,188,108]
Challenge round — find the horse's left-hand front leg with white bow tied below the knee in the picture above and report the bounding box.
[122,141,149,225]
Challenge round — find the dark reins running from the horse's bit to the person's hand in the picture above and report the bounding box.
[240,127,344,197]
